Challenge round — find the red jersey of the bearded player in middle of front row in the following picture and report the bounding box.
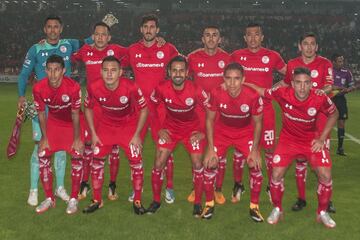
[150,80,209,131]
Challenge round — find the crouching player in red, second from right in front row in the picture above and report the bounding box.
[204,63,264,222]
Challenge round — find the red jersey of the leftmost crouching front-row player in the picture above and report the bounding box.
[33,76,81,126]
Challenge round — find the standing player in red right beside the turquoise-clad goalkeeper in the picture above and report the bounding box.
[71,22,127,200]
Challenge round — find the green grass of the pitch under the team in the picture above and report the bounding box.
[0,84,360,240]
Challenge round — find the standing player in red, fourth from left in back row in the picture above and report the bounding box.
[188,26,230,204]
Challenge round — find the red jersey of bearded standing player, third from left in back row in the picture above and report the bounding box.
[127,40,179,98]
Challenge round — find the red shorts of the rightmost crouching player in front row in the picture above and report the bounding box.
[272,138,331,168]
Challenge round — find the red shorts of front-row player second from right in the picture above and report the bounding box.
[214,125,254,157]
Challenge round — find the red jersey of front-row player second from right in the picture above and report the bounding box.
[209,85,263,131]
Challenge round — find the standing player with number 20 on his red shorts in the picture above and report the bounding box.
[231,23,286,202]
